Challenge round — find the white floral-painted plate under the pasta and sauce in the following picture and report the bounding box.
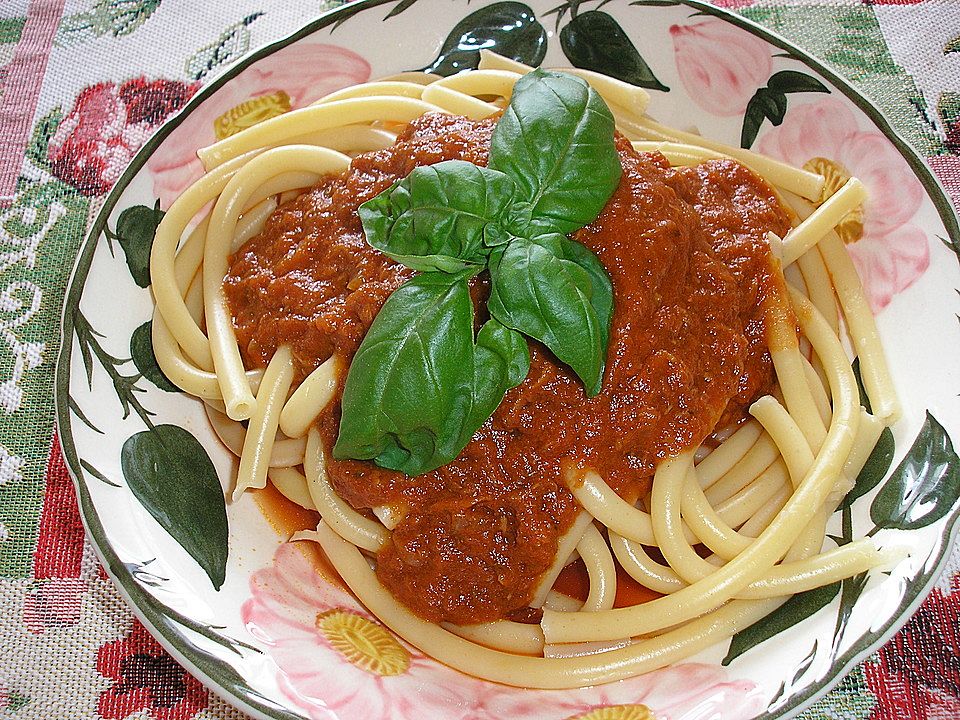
[57,0,960,720]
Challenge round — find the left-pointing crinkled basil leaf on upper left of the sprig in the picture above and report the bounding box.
[360,160,517,273]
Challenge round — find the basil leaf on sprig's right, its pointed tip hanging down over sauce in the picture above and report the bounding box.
[487,235,613,395]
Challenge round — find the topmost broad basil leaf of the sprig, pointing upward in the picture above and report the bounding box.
[489,70,622,237]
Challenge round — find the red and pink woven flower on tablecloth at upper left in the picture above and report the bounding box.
[47,77,199,195]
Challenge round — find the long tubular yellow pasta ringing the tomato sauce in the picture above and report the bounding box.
[151,51,899,688]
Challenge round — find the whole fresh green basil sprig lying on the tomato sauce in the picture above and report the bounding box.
[333,70,621,475]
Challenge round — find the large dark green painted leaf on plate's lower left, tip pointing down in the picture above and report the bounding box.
[120,425,228,590]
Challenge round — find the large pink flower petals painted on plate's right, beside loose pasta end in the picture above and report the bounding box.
[757,98,930,312]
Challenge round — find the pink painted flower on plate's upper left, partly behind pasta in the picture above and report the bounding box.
[147,41,370,208]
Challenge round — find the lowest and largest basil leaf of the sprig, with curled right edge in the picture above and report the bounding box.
[333,271,529,475]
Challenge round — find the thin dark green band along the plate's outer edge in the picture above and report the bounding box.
[55,0,960,720]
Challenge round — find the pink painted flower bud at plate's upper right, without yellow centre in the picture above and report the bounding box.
[670,19,773,116]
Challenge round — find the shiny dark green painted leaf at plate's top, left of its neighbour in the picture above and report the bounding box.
[422,2,547,76]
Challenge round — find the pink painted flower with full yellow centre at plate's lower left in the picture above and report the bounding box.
[242,544,484,720]
